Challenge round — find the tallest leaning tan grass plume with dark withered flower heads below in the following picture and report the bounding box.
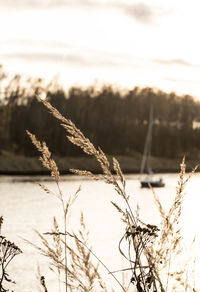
[36,99,164,292]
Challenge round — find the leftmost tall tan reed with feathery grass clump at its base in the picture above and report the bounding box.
[25,131,114,291]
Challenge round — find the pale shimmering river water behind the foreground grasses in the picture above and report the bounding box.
[0,174,200,292]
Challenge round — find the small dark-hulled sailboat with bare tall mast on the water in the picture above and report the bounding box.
[140,107,165,188]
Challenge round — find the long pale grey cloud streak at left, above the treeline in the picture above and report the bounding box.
[0,39,139,69]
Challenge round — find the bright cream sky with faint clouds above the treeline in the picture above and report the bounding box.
[0,0,200,99]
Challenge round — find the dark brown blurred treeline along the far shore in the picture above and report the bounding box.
[0,76,200,159]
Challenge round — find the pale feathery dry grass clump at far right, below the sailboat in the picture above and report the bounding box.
[152,158,198,291]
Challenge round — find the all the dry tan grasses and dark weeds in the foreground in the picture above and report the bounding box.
[1,94,198,292]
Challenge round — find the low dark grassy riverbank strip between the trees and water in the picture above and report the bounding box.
[0,152,198,175]
